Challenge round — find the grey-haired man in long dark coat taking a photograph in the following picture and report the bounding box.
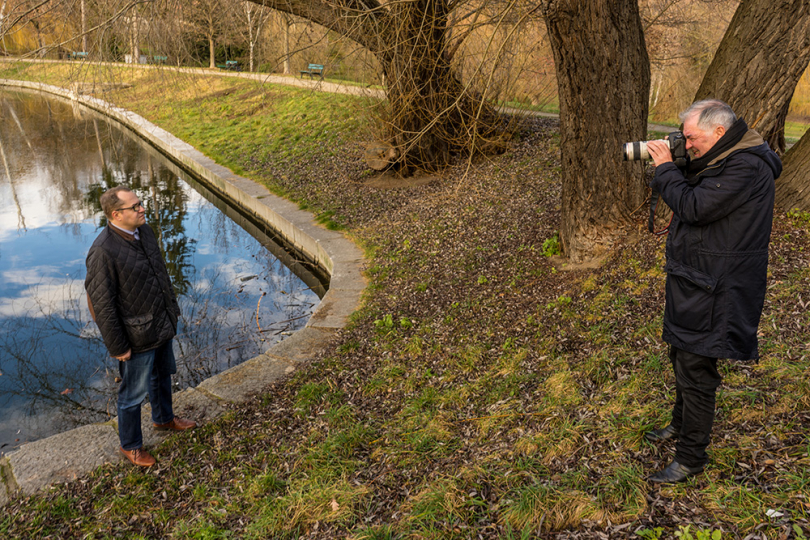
[646,99,782,483]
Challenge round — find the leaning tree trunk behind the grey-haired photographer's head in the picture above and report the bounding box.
[695,0,810,154]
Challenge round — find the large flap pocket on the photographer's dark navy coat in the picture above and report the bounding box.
[664,260,717,332]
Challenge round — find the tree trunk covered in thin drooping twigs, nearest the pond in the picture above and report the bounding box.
[251,0,505,173]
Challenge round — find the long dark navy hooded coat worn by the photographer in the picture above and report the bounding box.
[651,120,782,360]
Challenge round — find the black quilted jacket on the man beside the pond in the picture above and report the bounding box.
[84,225,180,356]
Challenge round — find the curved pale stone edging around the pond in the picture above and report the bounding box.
[0,79,366,507]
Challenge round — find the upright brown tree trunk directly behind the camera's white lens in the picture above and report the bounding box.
[542,0,650,262]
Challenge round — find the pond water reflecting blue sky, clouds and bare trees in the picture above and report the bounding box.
[0,90,325,455]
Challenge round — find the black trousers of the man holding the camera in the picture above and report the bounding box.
[669,347,722,467]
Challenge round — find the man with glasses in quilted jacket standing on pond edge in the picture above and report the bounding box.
[84,186,196,467]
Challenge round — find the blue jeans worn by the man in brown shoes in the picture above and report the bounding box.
[118,340,177,450]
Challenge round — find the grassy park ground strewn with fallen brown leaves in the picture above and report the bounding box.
[0,64,810,539]
